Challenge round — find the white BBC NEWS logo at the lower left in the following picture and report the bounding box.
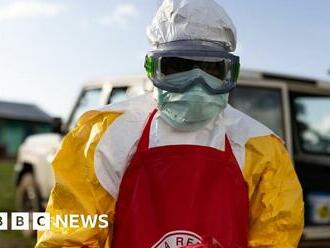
[0,212,109,231]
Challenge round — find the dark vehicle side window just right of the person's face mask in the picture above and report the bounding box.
[230,86,285,139]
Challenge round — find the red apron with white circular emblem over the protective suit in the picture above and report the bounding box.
[111,110,249,248]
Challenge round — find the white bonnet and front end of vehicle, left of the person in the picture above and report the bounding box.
[15,76,153,211]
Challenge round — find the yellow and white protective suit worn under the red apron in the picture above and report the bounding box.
[36,96,303,248]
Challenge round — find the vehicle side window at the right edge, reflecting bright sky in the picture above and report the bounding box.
[294,96,330,155]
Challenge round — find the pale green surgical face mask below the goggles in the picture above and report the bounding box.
[158,85,229,131]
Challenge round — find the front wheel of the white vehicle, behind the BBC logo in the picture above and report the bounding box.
[16,173,43,237]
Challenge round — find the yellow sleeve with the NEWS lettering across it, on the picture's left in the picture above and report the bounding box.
[36,111,120,248]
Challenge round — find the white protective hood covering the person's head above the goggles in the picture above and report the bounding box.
[147,0,236,52]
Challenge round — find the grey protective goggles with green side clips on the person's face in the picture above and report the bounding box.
[145,50,240,94]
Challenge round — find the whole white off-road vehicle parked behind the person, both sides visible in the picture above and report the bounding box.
[16,70,330,247]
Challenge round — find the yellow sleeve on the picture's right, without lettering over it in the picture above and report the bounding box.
[243,136,304,248]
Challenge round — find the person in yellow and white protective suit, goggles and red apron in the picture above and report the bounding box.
[36,0,303,248]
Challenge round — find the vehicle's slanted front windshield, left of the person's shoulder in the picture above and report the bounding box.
[68,88,102,129]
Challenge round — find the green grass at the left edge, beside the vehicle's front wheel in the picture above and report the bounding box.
[0,161,35,248]
